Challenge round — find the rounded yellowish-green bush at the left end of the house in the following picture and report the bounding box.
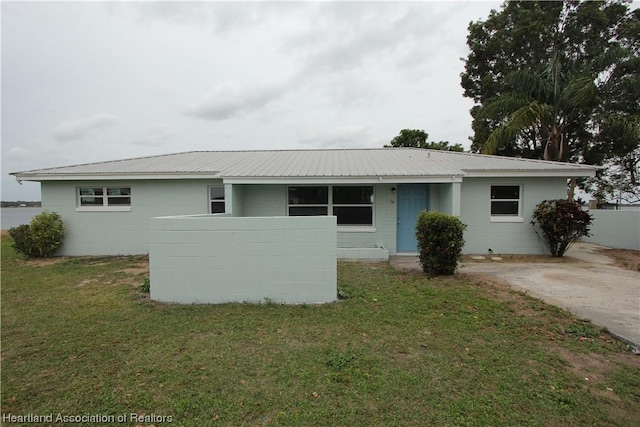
[9,210,65,258]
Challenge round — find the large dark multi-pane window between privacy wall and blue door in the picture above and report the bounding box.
[288,185,373,226]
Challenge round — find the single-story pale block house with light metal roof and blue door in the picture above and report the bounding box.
[12,148,597,259]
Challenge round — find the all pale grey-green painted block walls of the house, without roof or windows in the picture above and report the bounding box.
[41,178,566,255]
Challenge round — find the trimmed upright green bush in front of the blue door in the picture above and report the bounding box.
[416,211,467,276]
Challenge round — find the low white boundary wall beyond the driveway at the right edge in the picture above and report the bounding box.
[583,210,640,250]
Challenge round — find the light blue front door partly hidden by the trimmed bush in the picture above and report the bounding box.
[397,184,429,252]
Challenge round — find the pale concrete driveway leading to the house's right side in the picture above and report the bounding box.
[390,243,640,345]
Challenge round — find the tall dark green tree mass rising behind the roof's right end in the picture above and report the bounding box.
[461,1,640,201]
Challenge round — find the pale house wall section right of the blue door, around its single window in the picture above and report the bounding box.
[460,178,567,254]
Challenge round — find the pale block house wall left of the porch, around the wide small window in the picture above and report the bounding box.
[41,180,222,255]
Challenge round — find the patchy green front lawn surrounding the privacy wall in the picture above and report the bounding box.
[1,238,640,426]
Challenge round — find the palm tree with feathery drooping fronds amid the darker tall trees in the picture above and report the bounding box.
[481,55,639,199]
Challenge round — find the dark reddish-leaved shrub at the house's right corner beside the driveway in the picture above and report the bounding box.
[531,199,593,257]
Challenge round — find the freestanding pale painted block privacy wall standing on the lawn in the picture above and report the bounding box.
[149,215,337,304]
